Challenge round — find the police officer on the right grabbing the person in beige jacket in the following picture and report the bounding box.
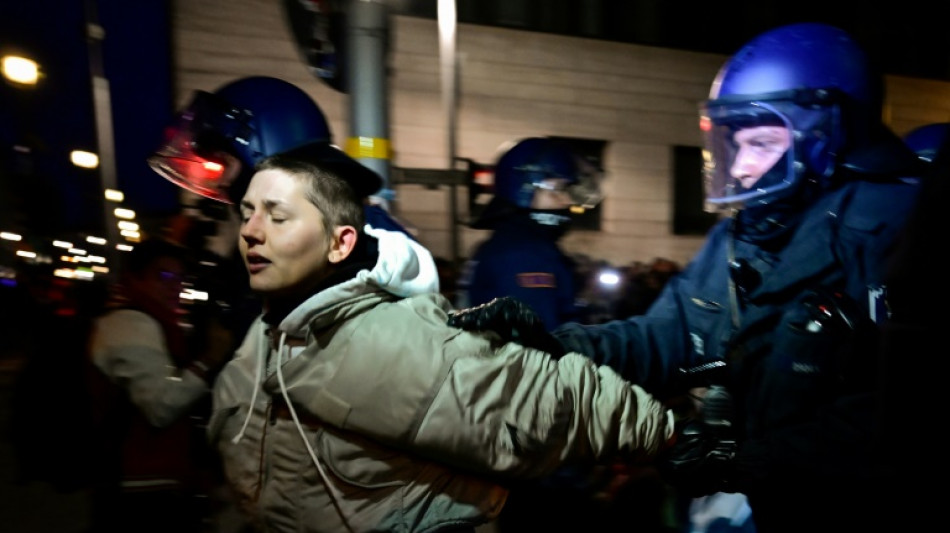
[451,23,920,533]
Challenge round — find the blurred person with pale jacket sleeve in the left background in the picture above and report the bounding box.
[88,238,235,533]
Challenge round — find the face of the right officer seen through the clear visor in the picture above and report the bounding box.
[729,126,792,189]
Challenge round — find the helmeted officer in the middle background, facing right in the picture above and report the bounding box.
[457,137,601,328]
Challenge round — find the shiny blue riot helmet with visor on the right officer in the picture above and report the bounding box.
[700,23,881,211]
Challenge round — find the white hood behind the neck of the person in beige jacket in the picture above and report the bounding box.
[279,225,439,335]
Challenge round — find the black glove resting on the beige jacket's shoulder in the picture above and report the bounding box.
[448,296,564,357]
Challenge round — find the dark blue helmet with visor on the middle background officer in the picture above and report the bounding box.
[472,137,603,229]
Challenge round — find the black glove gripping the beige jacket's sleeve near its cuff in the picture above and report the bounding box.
[659,386,737,498]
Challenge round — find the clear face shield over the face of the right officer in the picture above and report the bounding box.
[700,102,795,212]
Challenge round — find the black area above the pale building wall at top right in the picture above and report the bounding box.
[397,0,950,81]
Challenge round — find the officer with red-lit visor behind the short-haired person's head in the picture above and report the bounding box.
[148,76,412,336]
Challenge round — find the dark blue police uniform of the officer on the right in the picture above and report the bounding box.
[554,181,917,531]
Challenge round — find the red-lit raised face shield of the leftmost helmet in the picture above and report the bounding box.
[148,91,253,203]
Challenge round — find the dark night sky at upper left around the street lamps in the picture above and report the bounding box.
[0,0,178,243]
